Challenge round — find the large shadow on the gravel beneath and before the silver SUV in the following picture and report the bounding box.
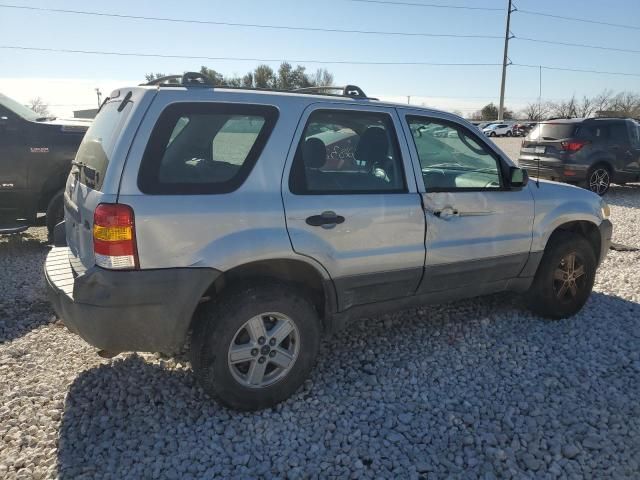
[58,293,640,480]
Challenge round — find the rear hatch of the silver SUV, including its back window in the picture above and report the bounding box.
[64,90,144,274]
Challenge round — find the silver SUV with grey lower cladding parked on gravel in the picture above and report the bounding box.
[46,75,612,410]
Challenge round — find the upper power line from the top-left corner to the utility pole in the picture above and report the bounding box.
[0,3,502,39]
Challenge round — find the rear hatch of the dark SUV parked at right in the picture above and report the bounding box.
[520,121,580,162]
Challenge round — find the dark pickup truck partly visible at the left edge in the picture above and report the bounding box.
[0,94,90,234]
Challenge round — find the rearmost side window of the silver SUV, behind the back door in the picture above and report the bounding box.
[138,103,277,194]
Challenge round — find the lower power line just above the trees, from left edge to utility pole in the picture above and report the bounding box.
[0,45,501,67]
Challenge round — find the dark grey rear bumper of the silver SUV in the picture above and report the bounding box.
[45,247,220,353]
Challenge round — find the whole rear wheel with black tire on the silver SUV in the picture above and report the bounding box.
[191,281,321,411]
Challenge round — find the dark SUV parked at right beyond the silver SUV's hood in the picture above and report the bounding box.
[519,118,640,195]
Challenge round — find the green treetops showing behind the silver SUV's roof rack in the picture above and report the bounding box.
[145,62,333,90]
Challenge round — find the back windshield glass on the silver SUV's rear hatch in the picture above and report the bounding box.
[76,100,131,191]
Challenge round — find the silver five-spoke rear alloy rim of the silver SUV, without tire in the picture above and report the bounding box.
[227,312,300,388]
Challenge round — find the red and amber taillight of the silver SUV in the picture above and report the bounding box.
[93,203,139,270]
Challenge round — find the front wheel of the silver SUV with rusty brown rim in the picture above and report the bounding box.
[528,232,596,320]
